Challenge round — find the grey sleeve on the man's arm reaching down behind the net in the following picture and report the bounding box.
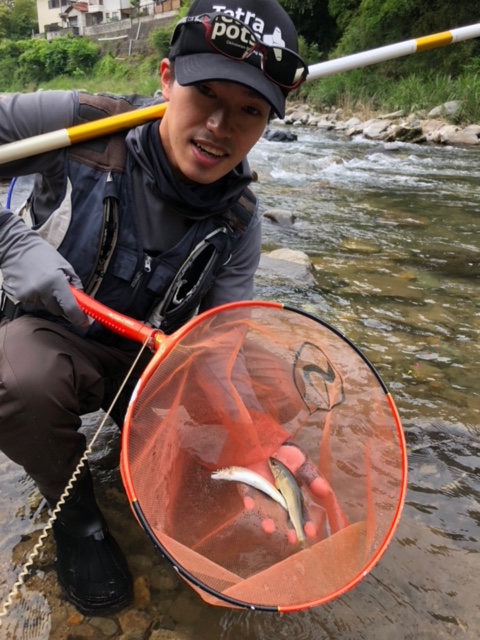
[200,206,262,311]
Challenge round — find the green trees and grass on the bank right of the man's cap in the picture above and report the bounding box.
[280,0,480,122]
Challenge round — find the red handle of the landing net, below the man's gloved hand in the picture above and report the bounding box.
[70,285,165,351]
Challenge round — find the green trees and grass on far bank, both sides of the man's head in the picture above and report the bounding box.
[0,0,480,122]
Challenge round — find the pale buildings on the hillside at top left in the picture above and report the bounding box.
[37,0,174,40]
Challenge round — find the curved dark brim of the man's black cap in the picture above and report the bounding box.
[175,53,285,118]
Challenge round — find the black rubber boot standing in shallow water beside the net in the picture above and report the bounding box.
[47,469,133,616]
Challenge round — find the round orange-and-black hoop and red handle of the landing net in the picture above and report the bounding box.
[72,288,407,613]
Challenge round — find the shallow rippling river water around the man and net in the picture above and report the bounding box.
[0,129,480,640]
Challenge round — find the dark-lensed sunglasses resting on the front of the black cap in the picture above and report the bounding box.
[170,13,308,91]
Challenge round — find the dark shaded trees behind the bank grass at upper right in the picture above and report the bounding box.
[280,0,480,74]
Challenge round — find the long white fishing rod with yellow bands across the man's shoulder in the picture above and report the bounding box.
[0,23,480,165]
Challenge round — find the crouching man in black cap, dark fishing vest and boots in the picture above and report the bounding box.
[0,0,308,615]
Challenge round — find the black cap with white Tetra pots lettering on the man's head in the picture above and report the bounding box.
[169,0,298,118]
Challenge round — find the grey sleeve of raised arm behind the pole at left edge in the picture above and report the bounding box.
[0,91,78,178]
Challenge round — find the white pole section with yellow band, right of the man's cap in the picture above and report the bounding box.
[307,24,480,81]
